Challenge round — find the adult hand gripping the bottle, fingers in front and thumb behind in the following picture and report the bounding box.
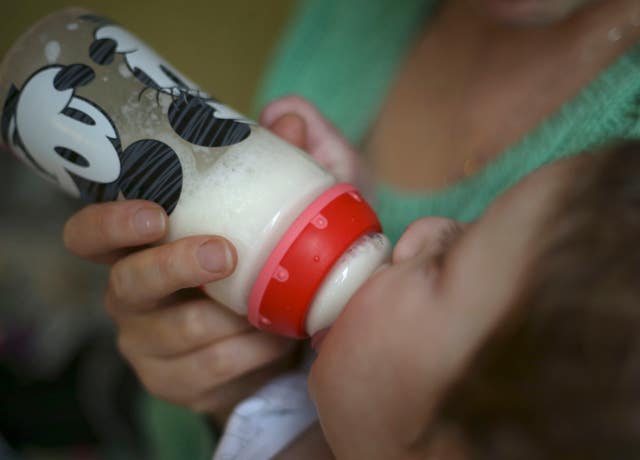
[63,96,360,424]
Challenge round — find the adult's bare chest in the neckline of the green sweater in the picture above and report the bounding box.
[365,3,635,191]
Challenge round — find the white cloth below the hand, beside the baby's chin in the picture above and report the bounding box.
[213,371,318,460]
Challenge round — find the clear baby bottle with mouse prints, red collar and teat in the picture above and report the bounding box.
[0,9,390,338]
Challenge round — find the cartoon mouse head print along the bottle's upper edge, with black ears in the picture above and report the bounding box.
[84,17,253,147]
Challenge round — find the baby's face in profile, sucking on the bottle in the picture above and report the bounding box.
[309,160,576,459]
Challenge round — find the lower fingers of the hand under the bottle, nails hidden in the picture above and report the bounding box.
[117,290,300,422]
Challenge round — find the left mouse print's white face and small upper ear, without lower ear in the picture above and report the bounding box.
[3,64,120,197]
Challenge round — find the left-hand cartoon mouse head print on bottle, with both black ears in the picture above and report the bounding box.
[0,64,182,214]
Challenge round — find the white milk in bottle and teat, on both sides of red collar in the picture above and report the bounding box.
[168,126,391,335]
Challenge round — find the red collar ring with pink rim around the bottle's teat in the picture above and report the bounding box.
[248,184,382,338]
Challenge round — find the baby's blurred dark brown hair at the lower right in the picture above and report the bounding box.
[439,142,640,460]
